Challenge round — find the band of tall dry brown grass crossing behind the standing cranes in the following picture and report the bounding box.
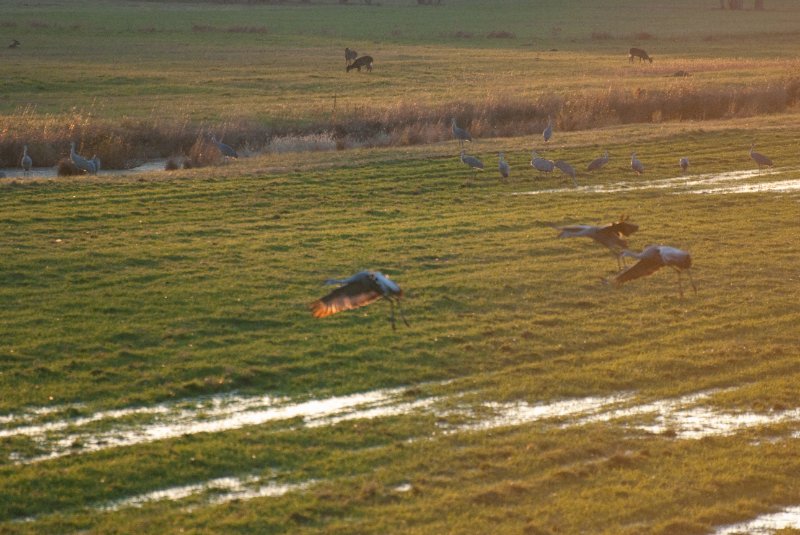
[6,77,800,164]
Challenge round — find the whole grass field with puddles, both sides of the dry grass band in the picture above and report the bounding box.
[0,0,800,535]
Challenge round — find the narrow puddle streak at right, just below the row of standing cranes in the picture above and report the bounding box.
[512,167,797,195]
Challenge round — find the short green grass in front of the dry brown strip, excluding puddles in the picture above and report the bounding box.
[0,124,800,532]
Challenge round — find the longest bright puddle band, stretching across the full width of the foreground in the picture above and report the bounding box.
[6,378,800,464]
